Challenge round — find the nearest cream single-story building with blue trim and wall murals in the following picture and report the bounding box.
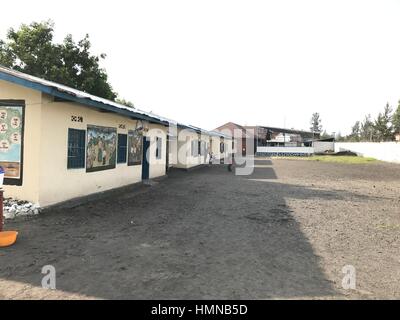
[0,66,230,207]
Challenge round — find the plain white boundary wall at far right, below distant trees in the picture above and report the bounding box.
[335,142,400,163]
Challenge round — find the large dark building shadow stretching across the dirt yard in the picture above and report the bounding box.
[0,161,368,299]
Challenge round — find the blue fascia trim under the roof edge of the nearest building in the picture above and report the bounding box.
[0,71,169,126]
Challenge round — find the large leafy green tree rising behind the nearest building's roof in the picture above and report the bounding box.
[0,21,117,100]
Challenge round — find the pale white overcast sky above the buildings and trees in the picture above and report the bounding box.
[0,0,400,134]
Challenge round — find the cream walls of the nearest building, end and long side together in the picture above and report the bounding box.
[0,81,166,207]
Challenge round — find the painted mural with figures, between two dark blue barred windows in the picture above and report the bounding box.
[86,125,117,172]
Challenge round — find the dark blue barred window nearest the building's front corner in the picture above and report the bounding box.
[67,129,86,169]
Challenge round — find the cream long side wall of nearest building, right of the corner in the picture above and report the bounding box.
[39,96,166,206]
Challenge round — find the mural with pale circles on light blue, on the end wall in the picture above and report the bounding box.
[0,106,23,180]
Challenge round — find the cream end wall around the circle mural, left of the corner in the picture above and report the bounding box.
[0,80,42,203]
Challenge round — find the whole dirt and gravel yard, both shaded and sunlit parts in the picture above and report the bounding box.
[0,159,400,299]
